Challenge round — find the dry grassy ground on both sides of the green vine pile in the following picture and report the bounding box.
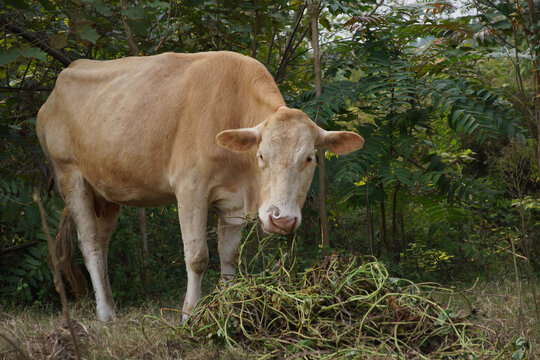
[0,277,540,360]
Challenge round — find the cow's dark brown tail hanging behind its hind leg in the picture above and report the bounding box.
[55,206,88,298]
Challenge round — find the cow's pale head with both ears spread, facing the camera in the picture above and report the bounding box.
[217,107,364,234]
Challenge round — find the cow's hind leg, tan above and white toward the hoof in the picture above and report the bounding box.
[57,166,119,321]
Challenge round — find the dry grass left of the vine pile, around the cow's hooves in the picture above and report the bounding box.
[0,301,238,360]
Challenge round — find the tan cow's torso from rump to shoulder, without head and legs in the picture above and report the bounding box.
[37,52,283,205]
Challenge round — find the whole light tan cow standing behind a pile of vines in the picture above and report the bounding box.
[36,51,364,321]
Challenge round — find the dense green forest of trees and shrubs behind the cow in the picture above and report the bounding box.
[0,0,540,358]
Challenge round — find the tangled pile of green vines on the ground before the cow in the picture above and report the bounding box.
[143,226,512,359]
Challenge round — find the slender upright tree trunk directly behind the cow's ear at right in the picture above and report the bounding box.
[308,0,330,247]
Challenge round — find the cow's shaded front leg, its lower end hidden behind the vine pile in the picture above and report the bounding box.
[218,218,242,280]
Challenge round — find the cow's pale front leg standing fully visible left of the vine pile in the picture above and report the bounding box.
[178,198,208,320]
